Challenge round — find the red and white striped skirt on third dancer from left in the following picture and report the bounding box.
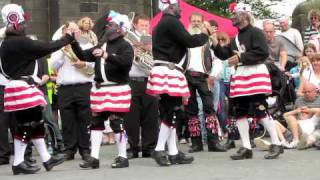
[146,66,190,97]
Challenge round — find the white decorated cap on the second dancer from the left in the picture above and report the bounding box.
[107,10,131,32]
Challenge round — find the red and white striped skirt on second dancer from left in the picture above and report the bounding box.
[90,84,131,112]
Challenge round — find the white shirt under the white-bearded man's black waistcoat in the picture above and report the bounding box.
[188,46,204,73]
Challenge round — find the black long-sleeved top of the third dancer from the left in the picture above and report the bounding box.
[152,14,208,63]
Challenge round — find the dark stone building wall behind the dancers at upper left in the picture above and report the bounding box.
[0,0,157,40]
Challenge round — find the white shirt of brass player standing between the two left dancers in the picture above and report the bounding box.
[51,50,94,85]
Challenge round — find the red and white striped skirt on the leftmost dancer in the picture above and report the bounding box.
[4,80,47,112]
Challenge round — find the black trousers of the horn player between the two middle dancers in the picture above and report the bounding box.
[124,80,159,152]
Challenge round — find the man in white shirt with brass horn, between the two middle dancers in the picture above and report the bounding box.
[124,15,159,159]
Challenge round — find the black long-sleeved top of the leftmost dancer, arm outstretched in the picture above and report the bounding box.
[0,35,74,79]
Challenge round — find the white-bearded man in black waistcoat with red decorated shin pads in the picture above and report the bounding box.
[186,13,226,153]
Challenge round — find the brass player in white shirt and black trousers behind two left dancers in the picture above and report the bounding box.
[51,22,94,160]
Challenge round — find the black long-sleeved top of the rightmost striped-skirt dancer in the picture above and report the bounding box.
[213,25,269,65]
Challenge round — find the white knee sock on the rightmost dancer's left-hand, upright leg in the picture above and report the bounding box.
[237,118,252,149]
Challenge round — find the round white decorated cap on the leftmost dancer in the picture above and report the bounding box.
[1,4,25,26]
